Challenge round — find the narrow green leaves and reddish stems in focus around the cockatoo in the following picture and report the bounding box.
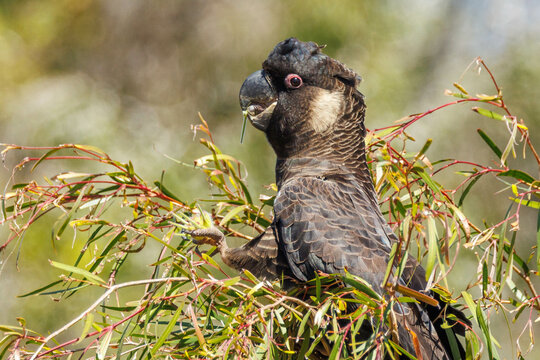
[0,59,540,359]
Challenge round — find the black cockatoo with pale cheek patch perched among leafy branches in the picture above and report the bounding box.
[193,38,467,360]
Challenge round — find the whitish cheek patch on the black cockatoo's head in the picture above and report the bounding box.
[310,89,343,133]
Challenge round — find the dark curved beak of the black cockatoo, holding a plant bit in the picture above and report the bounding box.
[240,70,277,131]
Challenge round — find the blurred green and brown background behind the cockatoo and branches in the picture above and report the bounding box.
[0,0,540,359]
